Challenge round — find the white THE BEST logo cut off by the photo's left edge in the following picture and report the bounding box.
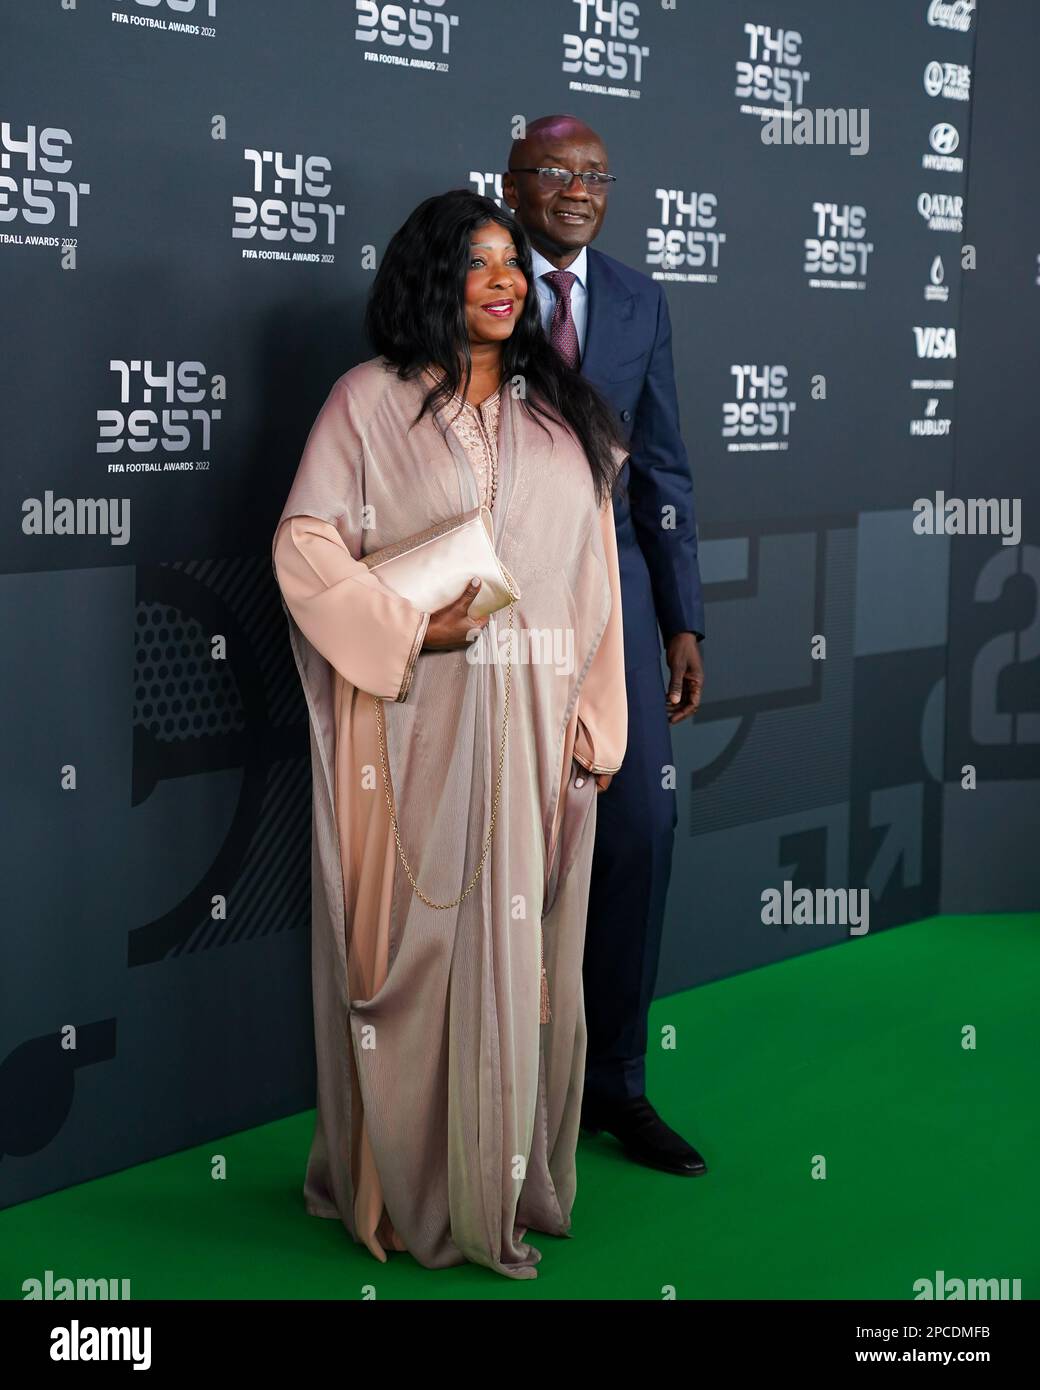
[0,121,90,227]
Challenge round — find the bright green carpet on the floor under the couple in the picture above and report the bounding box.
[0,915,1040,1300]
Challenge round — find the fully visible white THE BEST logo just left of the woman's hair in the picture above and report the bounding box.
[231,150,345,263]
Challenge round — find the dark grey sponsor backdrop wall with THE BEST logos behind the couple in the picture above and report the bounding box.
[0,0,1040,1205]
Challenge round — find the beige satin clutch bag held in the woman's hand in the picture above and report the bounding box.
[361,506,520,617]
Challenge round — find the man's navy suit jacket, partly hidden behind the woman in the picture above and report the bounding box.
[581,247,705,669]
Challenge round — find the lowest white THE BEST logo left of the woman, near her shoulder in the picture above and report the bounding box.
[97,359,227,473]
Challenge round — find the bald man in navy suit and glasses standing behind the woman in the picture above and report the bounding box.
[502,115,706,1176]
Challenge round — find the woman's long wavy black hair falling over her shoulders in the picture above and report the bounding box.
[364,188,621,505]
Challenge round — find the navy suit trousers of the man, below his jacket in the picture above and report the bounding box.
[583,660,677,1101]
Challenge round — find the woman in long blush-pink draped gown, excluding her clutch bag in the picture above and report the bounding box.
[273,190,627,1279]
